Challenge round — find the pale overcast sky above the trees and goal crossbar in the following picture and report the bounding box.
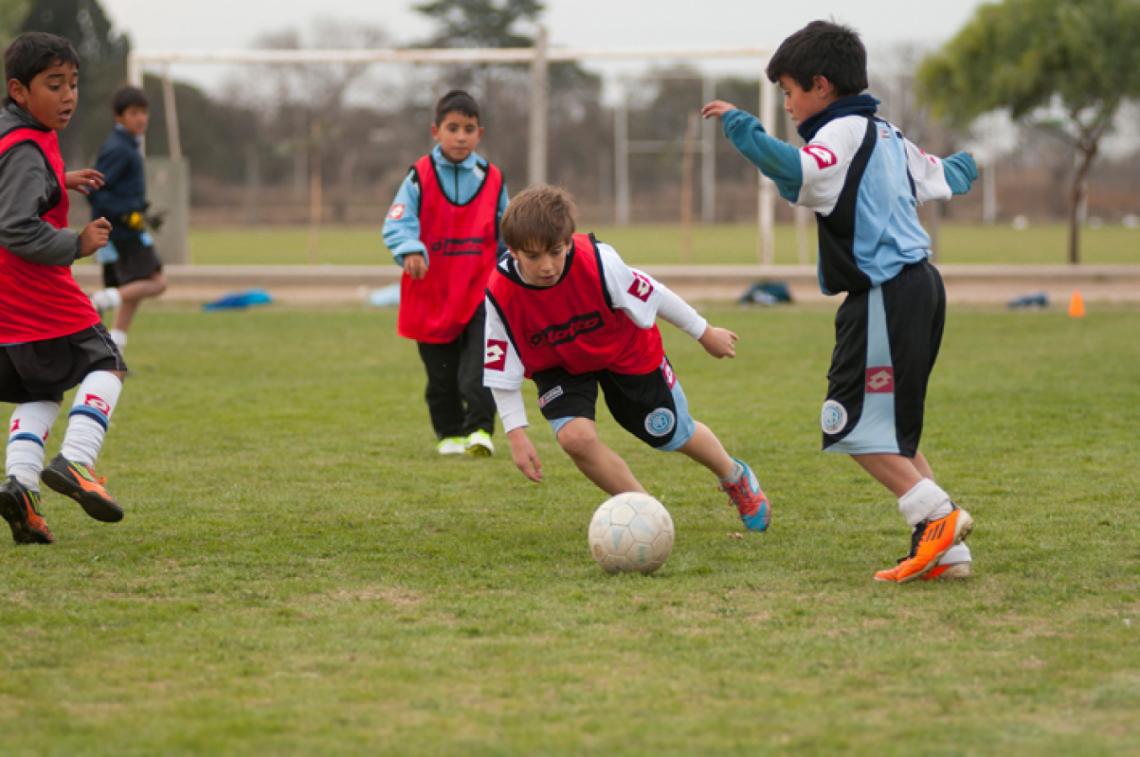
[101,0,983,88]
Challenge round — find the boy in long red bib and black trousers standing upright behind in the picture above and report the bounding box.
[384,90,507,456]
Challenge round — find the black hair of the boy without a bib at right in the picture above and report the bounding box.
[766,21,866,97]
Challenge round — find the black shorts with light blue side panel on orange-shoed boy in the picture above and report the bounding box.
[820,262,946,457]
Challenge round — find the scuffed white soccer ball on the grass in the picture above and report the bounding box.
[589,491,673,573]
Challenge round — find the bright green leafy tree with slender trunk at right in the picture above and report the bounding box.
[918,0,1140,263]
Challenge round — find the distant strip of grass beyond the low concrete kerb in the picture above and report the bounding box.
[180,223,1140,266]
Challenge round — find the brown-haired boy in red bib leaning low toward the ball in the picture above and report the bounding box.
[483,186,772,531]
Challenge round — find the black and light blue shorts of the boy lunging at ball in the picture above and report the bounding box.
[534,359,694,450]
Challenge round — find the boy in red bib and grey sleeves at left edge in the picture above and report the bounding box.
[0,32,127,544]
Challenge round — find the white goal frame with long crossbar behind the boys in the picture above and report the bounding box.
[127,42,776,264]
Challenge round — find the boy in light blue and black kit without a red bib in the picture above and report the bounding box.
[702,21,977,584]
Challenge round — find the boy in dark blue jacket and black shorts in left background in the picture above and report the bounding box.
[88,87,166,350]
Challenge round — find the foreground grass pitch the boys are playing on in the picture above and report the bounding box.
[0,306,1140,755]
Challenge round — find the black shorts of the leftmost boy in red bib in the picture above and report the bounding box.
[0,324,127,404]
